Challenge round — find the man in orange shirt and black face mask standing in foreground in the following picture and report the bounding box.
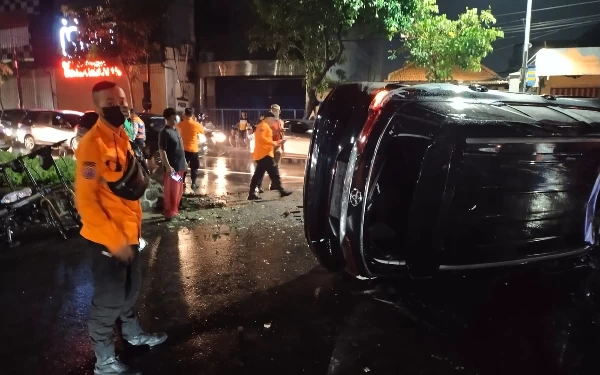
[75,81,167,375]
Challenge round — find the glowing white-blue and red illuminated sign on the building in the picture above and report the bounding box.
[59,18,123,78]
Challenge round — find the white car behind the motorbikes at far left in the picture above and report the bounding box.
[3,109,83,151]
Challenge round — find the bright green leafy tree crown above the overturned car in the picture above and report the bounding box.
[391,0,504,82]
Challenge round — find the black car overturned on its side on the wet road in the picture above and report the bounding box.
[303,83,600,278]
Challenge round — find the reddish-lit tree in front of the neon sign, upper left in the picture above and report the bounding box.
[62,0,167,108]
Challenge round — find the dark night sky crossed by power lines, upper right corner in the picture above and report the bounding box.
[437,0,600,72]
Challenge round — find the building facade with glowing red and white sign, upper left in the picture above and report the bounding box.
[0,0,195,113]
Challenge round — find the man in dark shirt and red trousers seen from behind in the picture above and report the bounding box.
[158,108,187,220]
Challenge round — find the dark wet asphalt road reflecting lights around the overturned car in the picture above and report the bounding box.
[0,153,600,375]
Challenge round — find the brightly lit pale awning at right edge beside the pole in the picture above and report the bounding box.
[535,47,600,77]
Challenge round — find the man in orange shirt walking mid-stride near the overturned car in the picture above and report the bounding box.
[248,112,292,200]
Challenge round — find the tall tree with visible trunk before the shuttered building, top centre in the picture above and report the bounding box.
[250,0,422,118]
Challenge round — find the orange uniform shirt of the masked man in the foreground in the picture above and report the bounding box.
[75,119,142,253]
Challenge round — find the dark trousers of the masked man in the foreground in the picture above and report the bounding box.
[88,241,142,361]
